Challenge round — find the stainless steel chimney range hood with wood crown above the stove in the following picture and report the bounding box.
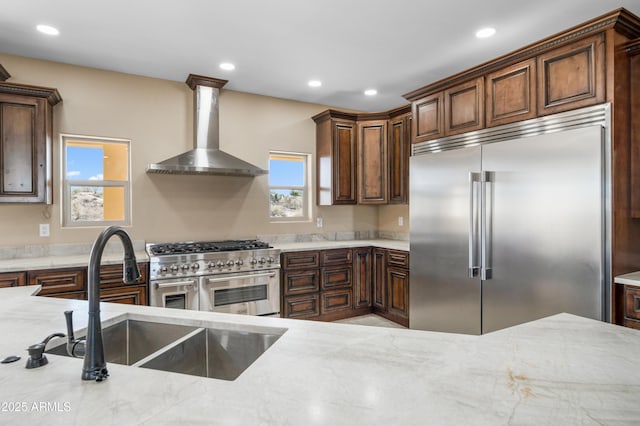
[147,74,269,176]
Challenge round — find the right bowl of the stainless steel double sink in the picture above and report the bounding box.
[140,328,282,380]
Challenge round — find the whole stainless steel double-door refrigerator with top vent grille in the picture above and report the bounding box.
[409,104,611,334]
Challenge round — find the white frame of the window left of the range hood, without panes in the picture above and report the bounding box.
[60,133,132,228]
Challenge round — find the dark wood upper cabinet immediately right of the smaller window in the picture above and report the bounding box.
[313,110,357,206]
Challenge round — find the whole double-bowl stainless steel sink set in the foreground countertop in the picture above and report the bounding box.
[46,318,286,380]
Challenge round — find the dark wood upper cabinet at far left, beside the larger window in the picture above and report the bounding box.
[0,82,61,204]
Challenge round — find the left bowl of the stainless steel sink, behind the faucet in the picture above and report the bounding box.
[46,319,197,365]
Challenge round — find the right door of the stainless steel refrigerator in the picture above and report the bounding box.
[481,126,604,333]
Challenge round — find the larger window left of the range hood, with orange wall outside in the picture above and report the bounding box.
[61,135,131,226]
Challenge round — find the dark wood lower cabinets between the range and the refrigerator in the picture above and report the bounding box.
[281,247,409,326]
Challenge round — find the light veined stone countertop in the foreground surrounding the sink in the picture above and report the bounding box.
[0,287,640,426]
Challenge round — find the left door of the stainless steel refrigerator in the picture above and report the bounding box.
[409,146,481,334]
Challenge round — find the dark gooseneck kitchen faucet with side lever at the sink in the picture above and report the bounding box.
[65,226,140,382]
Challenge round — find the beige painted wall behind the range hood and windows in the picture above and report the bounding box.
[0,54,400,245]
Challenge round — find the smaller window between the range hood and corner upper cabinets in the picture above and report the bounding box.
[269,152,310,221]
